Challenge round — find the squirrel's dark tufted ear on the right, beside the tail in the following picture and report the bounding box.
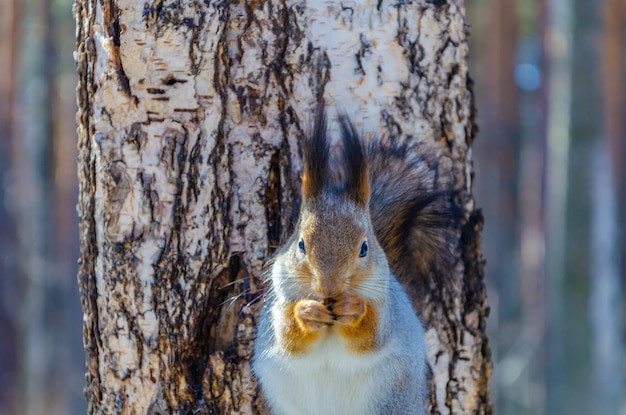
[339,114,370,207]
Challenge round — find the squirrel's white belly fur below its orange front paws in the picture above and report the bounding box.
[258,336,386,415]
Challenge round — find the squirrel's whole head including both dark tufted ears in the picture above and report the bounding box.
[287,112,388,300]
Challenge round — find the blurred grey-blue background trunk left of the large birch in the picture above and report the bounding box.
[11,0,72,415]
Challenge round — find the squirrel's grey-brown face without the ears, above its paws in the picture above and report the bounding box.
[288,194,382,300]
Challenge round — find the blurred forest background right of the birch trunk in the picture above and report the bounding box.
[468,0,626,414]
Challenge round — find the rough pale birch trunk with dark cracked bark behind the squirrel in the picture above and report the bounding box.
[75,0,491,414]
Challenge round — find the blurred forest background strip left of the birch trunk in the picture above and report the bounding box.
[0,0,86,415]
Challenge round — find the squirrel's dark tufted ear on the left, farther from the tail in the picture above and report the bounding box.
[302,104,329,200]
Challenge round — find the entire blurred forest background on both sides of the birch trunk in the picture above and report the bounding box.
[0,0,626,415]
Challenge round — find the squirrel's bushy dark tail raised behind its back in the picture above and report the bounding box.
[367,139,462,290]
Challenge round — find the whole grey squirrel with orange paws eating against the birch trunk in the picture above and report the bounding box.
[252,105,454,415]
